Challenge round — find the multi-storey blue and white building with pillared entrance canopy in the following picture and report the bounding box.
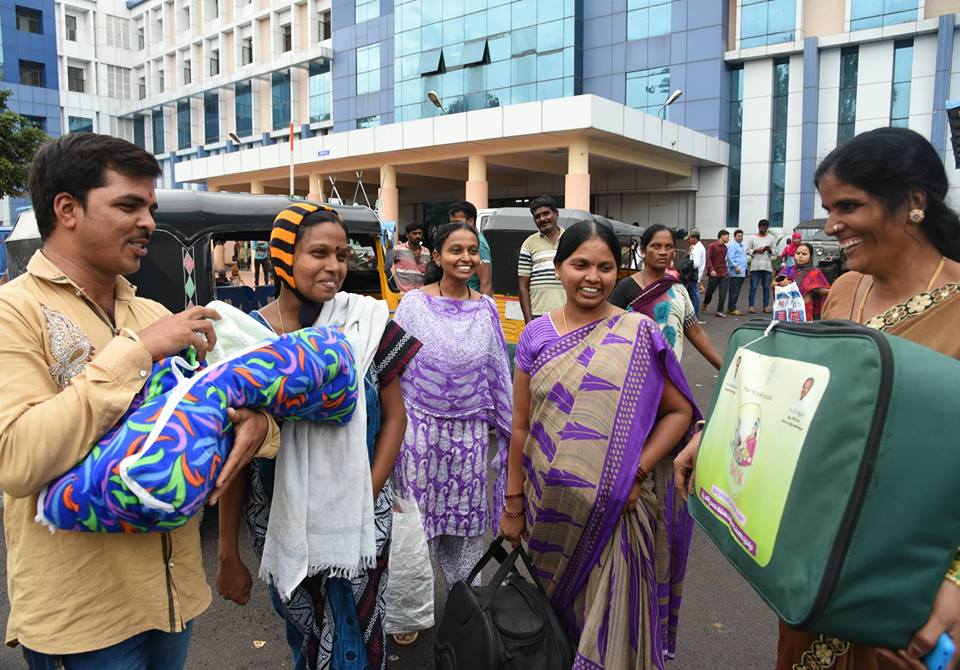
[0,0,960,235]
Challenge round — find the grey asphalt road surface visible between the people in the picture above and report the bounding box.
[0,291,776,670]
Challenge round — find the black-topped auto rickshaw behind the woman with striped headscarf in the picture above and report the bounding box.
[6,189,399,312]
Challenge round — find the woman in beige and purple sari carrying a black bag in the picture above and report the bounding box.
[500,222,699,670]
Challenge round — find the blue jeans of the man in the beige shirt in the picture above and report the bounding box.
[23,621,193,670]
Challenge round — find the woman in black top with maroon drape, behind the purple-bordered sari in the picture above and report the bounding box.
[608,228,723,370]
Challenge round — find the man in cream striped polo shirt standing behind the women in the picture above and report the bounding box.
[517,195,567,323]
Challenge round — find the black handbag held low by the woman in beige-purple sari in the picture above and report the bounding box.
[433,538,573,670]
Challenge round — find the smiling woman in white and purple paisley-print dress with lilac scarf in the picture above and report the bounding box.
[394,223,511,643]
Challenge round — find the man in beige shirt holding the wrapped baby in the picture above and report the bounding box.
[0,133,276,670]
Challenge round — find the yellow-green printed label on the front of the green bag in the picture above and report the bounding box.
[695,348,830,567]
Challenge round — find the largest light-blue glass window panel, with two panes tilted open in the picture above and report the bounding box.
[390,0,580,121]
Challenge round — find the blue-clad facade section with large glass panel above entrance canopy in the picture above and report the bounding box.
[330,0,728,139]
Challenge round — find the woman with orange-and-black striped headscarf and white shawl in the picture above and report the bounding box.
[217,203,420,670]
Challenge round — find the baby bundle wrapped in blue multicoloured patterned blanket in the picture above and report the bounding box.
[37,305,358,533]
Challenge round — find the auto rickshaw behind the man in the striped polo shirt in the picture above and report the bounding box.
[483,207,643,349]
